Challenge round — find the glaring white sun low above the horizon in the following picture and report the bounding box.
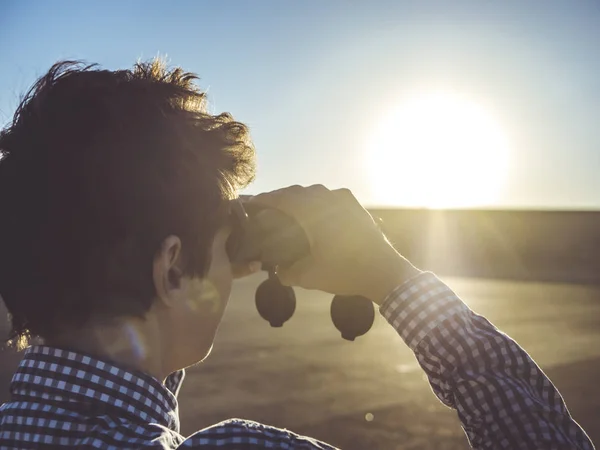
[365,92,509,208]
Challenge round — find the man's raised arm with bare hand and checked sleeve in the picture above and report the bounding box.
[250,185,593,450]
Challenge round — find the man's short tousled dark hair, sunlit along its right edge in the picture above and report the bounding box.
[0,60,255,347]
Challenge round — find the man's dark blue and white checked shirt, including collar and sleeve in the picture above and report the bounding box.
[0,273,593,450]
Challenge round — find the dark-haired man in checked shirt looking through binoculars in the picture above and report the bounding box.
[0,61,593,449]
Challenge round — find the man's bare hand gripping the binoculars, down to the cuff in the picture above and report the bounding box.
[247,185,419,304]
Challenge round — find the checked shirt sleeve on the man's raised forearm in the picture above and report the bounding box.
[380,273,594,450]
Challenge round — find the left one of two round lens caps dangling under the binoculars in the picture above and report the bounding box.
[255,277,296,328]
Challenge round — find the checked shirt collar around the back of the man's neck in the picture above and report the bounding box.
[10,345,179,432]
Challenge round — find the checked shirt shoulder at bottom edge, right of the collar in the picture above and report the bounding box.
[180,419,333,450]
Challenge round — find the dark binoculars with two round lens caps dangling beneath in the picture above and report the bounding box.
[226,199,375,341]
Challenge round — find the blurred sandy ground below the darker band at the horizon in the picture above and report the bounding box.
[0,276,600,450]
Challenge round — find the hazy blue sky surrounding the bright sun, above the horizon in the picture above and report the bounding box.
[0,0,600,209]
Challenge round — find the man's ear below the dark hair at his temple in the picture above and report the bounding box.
[152,236,182,306]
